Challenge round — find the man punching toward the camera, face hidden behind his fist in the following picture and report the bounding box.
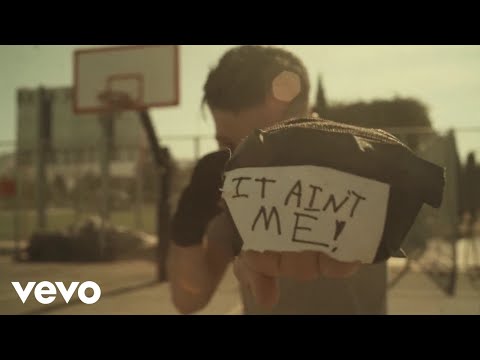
[167,46,382,314]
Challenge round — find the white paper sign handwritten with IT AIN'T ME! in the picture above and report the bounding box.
[223,166,390,263]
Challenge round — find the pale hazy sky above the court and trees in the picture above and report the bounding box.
[0,45,480,157]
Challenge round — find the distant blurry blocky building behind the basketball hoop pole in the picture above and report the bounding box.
[17,87,146,180]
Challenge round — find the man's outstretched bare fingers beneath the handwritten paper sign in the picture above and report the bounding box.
[234,251,360,308]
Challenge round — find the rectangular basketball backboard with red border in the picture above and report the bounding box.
[74,45,179,113]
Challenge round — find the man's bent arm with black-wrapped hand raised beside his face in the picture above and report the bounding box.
[167,151,233,314]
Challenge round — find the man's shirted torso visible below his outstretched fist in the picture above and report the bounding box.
[242,263,387,315]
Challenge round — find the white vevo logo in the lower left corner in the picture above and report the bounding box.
[12,281,102,305]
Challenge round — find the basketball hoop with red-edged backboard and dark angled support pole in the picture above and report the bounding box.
[73,45,180,281]
